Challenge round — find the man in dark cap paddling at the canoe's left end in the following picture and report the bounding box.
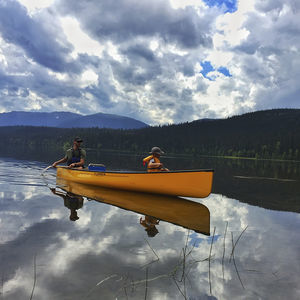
[52,137,86,169]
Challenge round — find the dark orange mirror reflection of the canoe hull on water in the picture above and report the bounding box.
[56,178,210,235]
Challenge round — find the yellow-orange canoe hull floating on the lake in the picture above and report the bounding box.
[57,167,213,198]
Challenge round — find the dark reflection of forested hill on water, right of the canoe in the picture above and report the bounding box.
[213,161,300,212]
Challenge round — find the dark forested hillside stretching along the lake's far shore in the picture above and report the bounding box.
[0,109,300,160]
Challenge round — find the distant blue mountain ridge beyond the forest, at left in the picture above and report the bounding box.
[0,111,148,129]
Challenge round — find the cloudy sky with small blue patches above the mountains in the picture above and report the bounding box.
[0,0,300,125]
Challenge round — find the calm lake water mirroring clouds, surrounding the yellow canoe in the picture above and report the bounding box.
[0,154,300,300]
